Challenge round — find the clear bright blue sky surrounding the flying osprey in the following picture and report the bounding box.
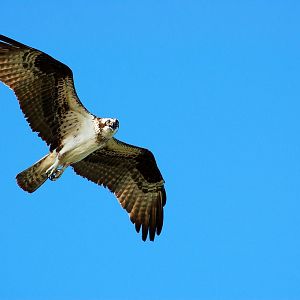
[0,0,300,300]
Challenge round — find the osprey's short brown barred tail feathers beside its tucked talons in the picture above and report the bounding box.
[16,153,55,193]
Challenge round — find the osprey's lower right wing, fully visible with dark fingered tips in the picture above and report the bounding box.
[72,138,166,241]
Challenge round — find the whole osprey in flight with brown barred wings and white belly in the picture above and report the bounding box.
[0,35,166,241]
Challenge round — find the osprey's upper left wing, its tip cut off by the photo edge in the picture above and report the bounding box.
[0,35,88,150]
